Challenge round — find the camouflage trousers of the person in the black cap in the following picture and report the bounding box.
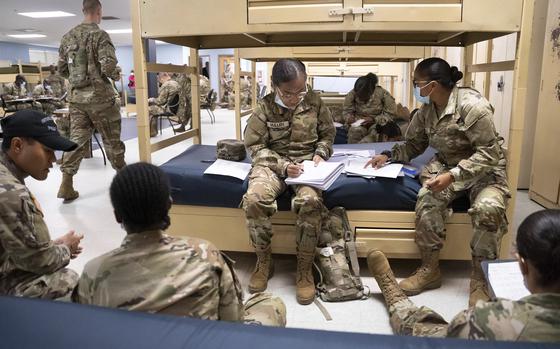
[0,268,79,299]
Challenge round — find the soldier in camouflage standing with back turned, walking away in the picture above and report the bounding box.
[57,0,125,201]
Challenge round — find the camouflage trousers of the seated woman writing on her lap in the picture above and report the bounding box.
[243,166,326,253]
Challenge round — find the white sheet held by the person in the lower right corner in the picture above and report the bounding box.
[488,261,530,300]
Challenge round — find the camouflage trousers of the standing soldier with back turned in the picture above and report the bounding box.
[60,102,126,175]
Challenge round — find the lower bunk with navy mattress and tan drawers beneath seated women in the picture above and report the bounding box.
[161,143,511,260]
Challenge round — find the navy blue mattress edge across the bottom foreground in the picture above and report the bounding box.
[0,297,558,349]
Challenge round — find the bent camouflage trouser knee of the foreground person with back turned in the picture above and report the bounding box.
[243,293,286,327]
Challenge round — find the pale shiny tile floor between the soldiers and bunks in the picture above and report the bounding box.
[27,110,541,334]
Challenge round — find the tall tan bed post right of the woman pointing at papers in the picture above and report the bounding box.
[501,0,536,257]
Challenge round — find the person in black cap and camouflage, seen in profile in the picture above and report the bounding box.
[0,110,82,299]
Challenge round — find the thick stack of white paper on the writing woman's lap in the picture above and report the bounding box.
[286,161,344,190]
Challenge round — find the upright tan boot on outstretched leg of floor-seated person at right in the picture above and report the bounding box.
[367,250,408,307]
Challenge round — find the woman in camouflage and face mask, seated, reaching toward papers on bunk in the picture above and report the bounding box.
[369,58,510,306]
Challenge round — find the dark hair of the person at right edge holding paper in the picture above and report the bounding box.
[516,210,560,286]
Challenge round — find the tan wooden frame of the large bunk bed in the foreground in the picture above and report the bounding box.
[132,0,535,260]
